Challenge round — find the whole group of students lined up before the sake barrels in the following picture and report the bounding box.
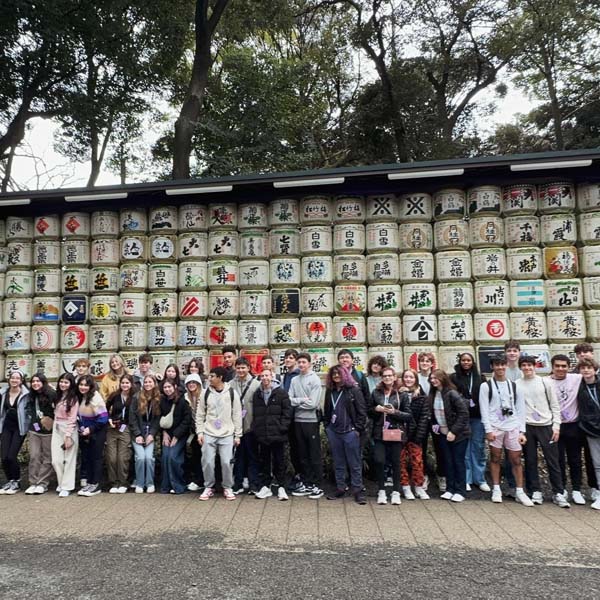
[0,342,600,509]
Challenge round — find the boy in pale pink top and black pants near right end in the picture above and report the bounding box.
[550,354,585,504]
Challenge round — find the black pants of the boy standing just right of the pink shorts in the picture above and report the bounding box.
[523,425,564,494]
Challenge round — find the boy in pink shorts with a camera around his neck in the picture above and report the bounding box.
[479,354,533,506]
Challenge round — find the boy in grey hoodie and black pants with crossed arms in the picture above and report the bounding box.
[289,352,323,500]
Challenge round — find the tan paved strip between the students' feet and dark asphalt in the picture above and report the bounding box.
[0,492,600,552]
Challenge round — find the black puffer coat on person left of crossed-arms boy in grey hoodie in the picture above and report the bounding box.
[251,386,292,444]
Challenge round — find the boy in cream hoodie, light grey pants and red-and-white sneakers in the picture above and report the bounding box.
[196,367,242,500]
